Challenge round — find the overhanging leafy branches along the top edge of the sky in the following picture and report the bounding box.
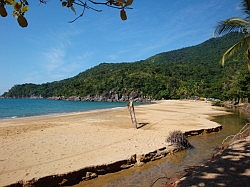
[0,0,133,27]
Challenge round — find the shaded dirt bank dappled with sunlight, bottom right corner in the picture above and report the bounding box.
[176,124,250,187]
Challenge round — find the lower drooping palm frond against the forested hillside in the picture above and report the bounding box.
[220,34,250,66]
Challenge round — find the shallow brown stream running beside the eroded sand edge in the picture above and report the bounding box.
[75,111,249,187]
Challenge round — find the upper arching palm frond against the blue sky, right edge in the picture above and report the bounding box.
[214,18,250,35]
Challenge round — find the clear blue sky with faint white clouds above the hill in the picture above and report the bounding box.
[0,0,242,95]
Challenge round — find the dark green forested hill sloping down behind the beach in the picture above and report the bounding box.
[2,33,250,101]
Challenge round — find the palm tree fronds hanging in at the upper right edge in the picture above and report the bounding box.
[214,0,250,71]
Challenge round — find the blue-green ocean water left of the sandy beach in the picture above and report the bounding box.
[0,98,127,120]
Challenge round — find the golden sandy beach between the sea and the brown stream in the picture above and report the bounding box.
[0,100,228,186]
